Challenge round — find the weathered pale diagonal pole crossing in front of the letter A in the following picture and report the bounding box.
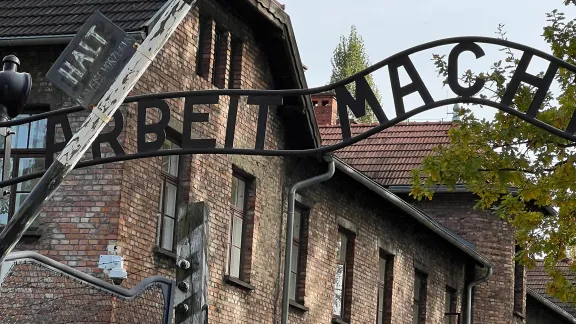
[0,0,196,262]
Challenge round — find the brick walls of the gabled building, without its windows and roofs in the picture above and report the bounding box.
[3,0,568,324]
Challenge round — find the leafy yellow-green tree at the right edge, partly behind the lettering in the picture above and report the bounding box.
[411,1,576,302]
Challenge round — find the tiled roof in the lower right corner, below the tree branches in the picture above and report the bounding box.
[526,261,576,317]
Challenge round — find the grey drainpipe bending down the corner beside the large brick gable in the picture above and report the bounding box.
[282,156,336,324]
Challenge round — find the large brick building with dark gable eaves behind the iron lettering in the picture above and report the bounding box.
[0,0,572,324]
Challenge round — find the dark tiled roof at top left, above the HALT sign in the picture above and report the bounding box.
[0,0,166,37]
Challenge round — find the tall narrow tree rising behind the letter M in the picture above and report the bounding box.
[329,25,382,123]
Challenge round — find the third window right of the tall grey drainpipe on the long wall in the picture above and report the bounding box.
[376,251,394,324]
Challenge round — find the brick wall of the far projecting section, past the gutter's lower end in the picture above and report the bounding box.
[401,193,515,323]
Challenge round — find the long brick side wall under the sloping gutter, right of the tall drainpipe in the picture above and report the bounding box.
[282,159,469,324]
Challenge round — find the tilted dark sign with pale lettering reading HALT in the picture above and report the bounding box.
[46,11,136,109]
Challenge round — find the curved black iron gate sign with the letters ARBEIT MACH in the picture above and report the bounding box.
[0,37,576,187]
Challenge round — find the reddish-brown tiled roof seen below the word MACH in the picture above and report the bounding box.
[320,122,453,186]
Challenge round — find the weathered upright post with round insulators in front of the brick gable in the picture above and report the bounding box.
[174,202,210,324]
